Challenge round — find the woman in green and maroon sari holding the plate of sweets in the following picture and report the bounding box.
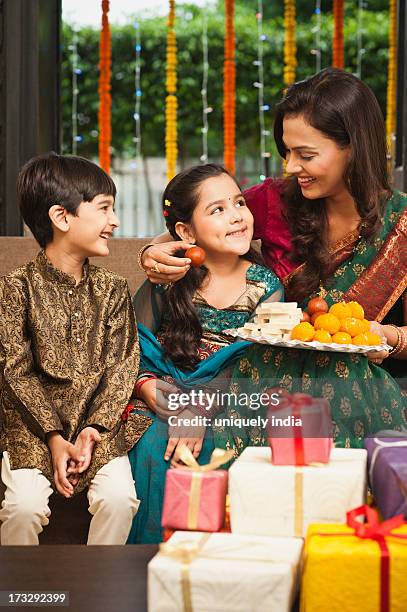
[139,69,407,451]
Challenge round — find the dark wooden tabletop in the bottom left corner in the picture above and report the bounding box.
[0,544,158,612]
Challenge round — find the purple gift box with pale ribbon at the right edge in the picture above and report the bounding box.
[365,437,407,519]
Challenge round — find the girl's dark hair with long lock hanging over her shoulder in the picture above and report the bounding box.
[162,164,255,370]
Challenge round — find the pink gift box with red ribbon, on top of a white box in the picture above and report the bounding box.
[267,392,333,465]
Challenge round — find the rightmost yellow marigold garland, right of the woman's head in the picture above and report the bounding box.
[386,0,397,163]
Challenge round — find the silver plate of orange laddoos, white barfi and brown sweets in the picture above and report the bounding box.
[225,297,391,355]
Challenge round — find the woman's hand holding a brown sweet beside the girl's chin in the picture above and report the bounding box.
[141,240,194,284]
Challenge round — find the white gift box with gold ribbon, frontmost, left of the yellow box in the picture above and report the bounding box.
[148,531,303,612]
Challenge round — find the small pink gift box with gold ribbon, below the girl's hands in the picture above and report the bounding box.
[161,468,228,531]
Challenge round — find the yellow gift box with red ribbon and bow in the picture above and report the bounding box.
[300,506,407,612]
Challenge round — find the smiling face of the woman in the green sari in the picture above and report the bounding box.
[283,115,351,200]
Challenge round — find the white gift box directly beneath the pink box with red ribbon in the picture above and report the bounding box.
[229,447,367,537]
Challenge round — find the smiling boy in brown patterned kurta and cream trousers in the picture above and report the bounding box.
[0,153,150,545]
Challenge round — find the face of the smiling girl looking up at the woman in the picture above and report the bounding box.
[176,174,253,257]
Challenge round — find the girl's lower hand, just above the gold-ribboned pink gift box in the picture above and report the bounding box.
[164,408,206,467]
